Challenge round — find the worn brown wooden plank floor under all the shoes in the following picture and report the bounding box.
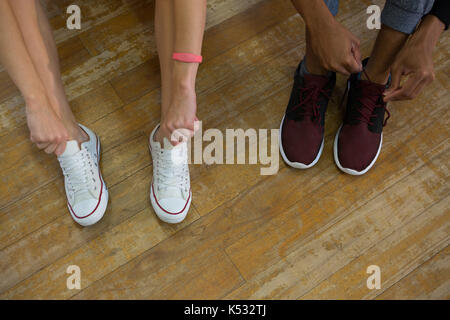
[0,0,450,299]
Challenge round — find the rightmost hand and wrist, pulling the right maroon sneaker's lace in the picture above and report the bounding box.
[384,15,445,101]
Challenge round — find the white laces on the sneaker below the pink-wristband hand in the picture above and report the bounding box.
[156,148,189,192]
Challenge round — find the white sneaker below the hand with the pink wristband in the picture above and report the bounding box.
[150,125,192,223]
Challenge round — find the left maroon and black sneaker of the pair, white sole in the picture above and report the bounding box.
[279,65,336,169]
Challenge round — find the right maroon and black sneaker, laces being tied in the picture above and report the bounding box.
[334,70,390,175]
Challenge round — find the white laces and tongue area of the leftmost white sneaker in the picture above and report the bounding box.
[58,148,97,195]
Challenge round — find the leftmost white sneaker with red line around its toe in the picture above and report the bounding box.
[58,125,108,226]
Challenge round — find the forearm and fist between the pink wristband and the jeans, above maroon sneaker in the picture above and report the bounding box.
[292,0,362,75]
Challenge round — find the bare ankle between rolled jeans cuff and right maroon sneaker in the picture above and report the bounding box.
[363,25,409,84]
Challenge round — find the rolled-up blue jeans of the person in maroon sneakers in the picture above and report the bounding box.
[324,0,434,34]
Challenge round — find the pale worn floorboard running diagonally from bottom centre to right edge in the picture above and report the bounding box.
[226,150,449,299]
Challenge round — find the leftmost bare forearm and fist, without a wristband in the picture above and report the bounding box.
[0,1,68,154]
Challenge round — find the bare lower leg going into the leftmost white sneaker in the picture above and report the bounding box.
[10,0,88,142]
